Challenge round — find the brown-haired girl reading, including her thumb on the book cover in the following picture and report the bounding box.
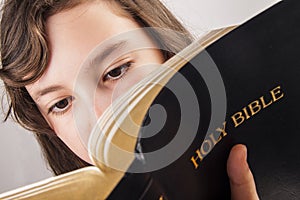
[0,0,257,199]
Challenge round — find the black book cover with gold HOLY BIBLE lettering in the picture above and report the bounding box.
[109,1,300,200]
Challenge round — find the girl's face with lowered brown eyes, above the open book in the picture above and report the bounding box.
[26,1,164,163]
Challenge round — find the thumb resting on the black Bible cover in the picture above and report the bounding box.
[227,144,259,200]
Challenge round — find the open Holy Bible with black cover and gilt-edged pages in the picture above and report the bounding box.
[0,1,300,200]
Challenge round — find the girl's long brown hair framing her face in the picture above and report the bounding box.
[0,0,192,175]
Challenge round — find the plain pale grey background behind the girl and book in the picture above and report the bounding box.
[0,0,279,193]
